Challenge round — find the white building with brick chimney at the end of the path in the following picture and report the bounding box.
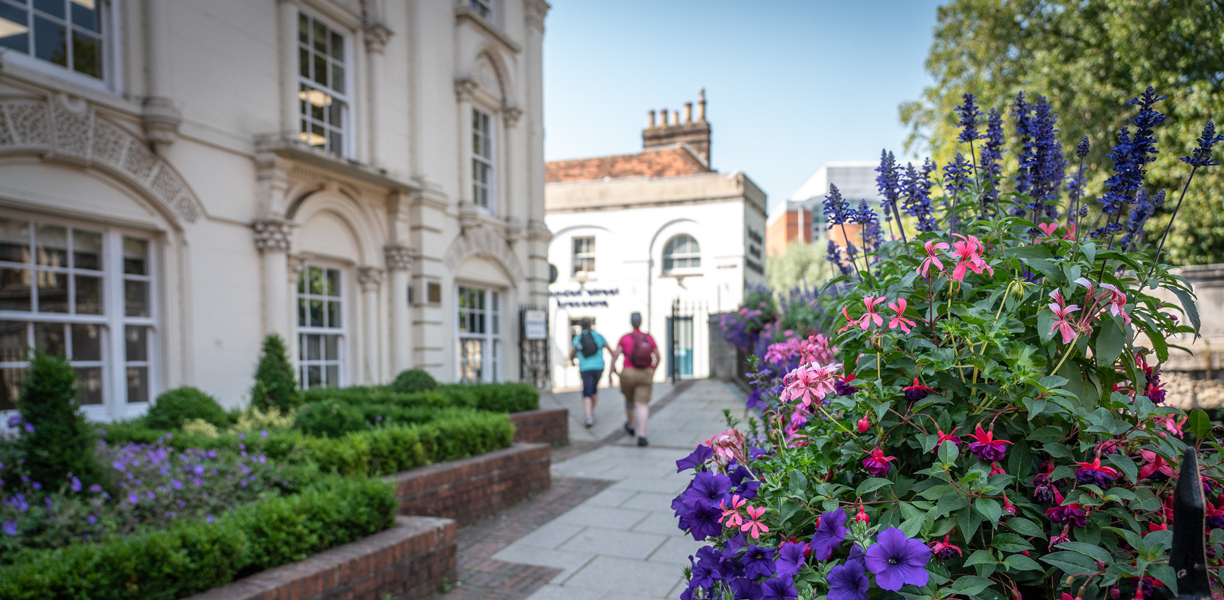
[545,94,766,387]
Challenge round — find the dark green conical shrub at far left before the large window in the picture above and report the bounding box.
[17,350,102,485]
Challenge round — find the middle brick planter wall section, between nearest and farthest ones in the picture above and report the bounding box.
[387,443,552,527]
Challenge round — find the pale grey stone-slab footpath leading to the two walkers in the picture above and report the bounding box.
[489,380,745,600]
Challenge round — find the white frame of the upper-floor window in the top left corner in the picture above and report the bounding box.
[0,0,121,93]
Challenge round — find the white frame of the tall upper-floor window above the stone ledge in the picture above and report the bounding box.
[294,9,356,158]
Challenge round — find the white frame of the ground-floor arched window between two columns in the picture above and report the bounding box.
[293,262,350,389]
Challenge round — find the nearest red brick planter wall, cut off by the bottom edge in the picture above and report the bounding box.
[188,517,458,600]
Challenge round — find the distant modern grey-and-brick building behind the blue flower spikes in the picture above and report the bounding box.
[765,162,884,256]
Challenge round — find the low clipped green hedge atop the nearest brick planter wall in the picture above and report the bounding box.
[0,478,398,600]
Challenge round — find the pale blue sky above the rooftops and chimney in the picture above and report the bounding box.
[545,0,940,213]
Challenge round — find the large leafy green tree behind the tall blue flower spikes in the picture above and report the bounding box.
[901,0,1224,264]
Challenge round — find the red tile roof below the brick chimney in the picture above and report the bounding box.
[545,146,712,184]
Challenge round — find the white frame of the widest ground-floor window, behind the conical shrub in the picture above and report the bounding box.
[0,211,162,420]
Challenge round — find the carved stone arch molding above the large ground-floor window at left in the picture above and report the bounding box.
[0,96,203,223]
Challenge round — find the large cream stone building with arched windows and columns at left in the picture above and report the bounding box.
[0,0,550,419]
